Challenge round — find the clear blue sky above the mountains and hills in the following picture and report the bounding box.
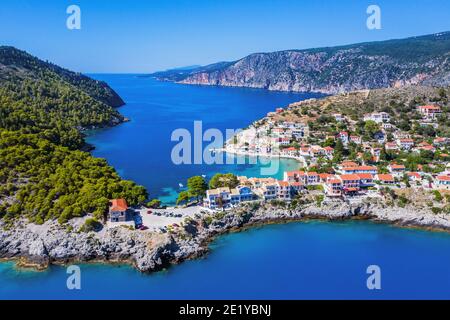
[0,0,450,73]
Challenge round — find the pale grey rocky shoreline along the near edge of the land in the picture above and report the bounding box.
[0,200,450,273]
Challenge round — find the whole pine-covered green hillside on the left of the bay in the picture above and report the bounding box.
[0,47,147,223]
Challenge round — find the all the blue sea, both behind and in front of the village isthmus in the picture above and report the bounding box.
[0,75,450,299]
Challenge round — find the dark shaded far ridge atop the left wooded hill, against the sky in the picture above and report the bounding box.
[0,46,125,108]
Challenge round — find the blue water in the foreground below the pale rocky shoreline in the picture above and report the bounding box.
[0,222,450,299]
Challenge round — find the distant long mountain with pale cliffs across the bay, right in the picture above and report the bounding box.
[152,32,450,94]
